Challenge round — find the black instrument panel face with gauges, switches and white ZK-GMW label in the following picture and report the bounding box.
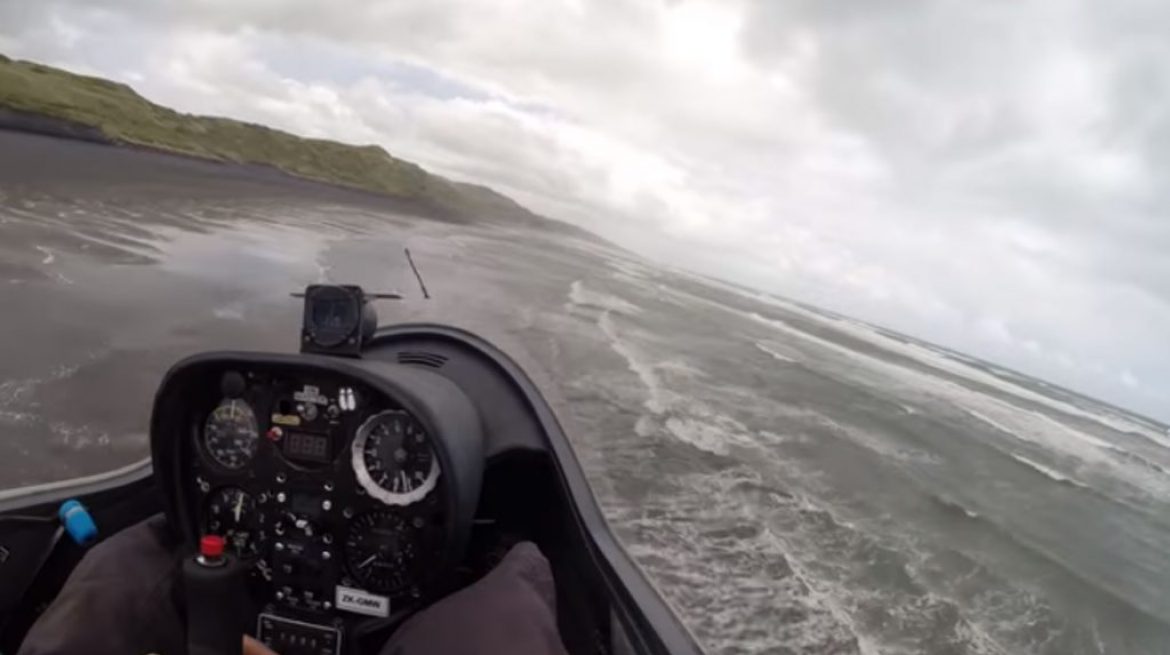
[190,370,447,620]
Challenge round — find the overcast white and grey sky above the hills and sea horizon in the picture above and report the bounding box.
[0,0,1170,420]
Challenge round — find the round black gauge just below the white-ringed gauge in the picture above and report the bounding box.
[345,510,417,594]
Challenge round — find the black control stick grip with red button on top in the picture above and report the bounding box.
[183,536,254,655]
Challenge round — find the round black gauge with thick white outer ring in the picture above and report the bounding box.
[351,409,439,505]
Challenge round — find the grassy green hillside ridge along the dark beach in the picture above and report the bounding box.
[0,55,593,237]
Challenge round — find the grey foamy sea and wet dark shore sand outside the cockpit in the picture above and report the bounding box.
[0,133,1170,654]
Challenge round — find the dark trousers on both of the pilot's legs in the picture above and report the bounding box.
[18,517,565,655]
